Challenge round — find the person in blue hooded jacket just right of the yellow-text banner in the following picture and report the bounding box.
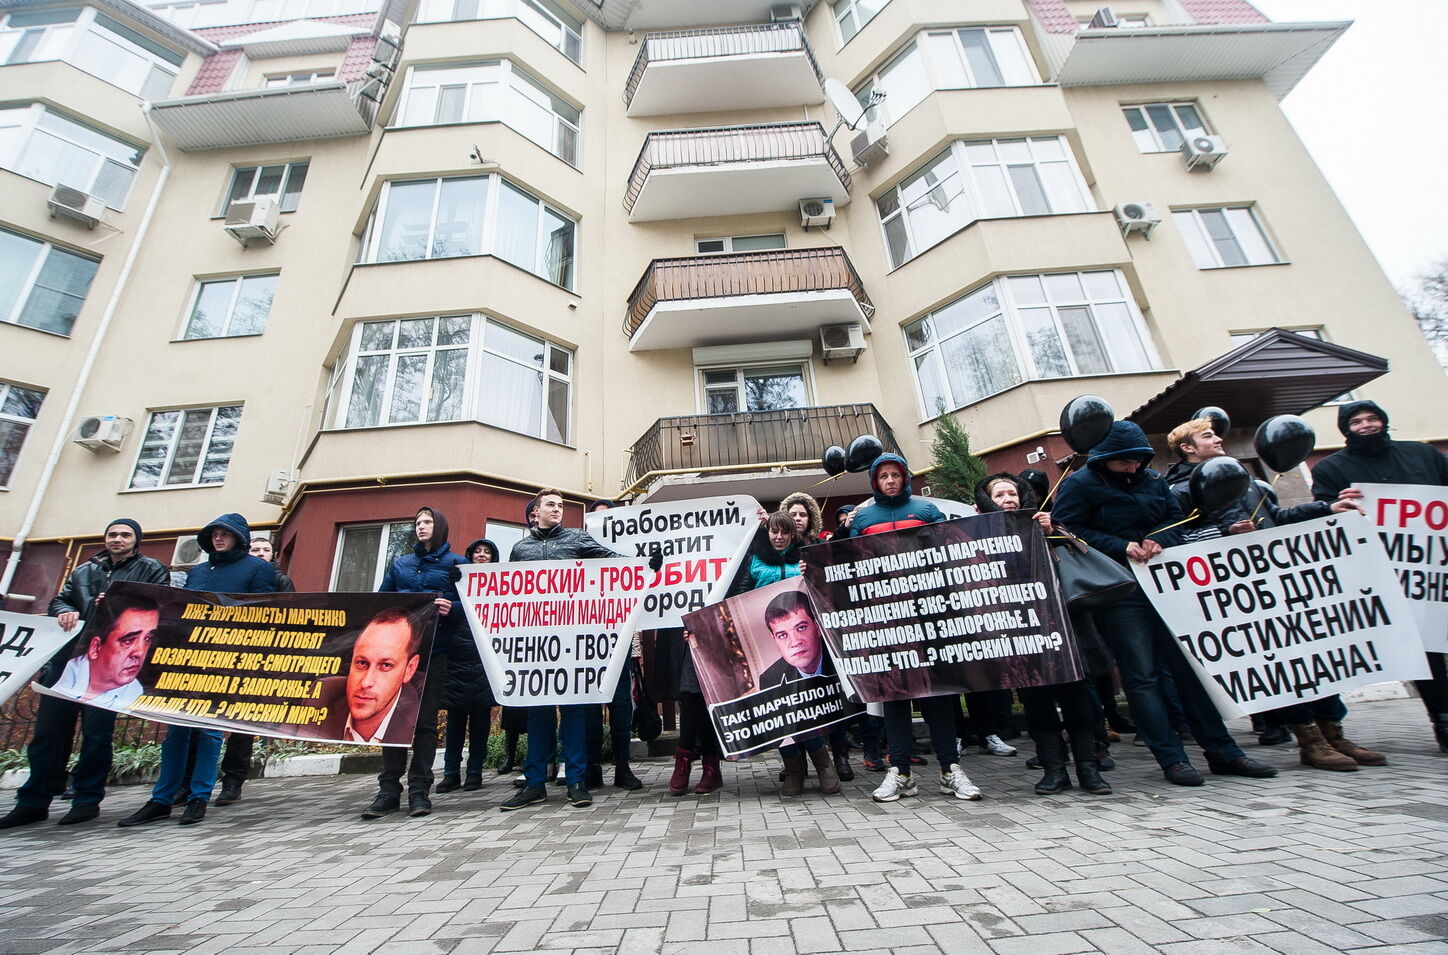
[362,508,460,819]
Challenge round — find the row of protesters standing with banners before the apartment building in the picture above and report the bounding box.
[0,401,1448,828]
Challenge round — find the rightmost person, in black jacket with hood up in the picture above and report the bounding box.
[1312,401,1448,752]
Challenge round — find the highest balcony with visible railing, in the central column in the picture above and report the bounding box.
[624,20,824,116]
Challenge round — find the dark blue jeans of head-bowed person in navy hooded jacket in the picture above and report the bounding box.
[1096,589,1242,768]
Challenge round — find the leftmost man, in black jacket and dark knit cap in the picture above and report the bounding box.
[0,518,171,829]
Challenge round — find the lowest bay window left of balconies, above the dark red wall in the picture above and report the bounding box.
[332,315,573,444]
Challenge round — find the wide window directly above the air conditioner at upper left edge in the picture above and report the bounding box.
[0,103,146,208]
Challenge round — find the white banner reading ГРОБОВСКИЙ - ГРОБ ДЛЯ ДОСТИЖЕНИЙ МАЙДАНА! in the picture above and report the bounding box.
[1131,511,1428,716]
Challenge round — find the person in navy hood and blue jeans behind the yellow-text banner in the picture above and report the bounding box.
[116,514,277,828]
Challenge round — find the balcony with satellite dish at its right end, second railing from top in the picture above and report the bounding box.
[624,122,850,223]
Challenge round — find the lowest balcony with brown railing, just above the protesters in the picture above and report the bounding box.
[624,404,899,501]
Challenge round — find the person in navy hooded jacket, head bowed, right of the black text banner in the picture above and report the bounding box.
[1051,421,1277,786]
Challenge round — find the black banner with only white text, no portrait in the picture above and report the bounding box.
[804,512,1083,703]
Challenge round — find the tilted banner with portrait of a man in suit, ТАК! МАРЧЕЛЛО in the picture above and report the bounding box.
[683,577,863,758]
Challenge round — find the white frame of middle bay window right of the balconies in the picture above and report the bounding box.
[875,136,1096,271]
